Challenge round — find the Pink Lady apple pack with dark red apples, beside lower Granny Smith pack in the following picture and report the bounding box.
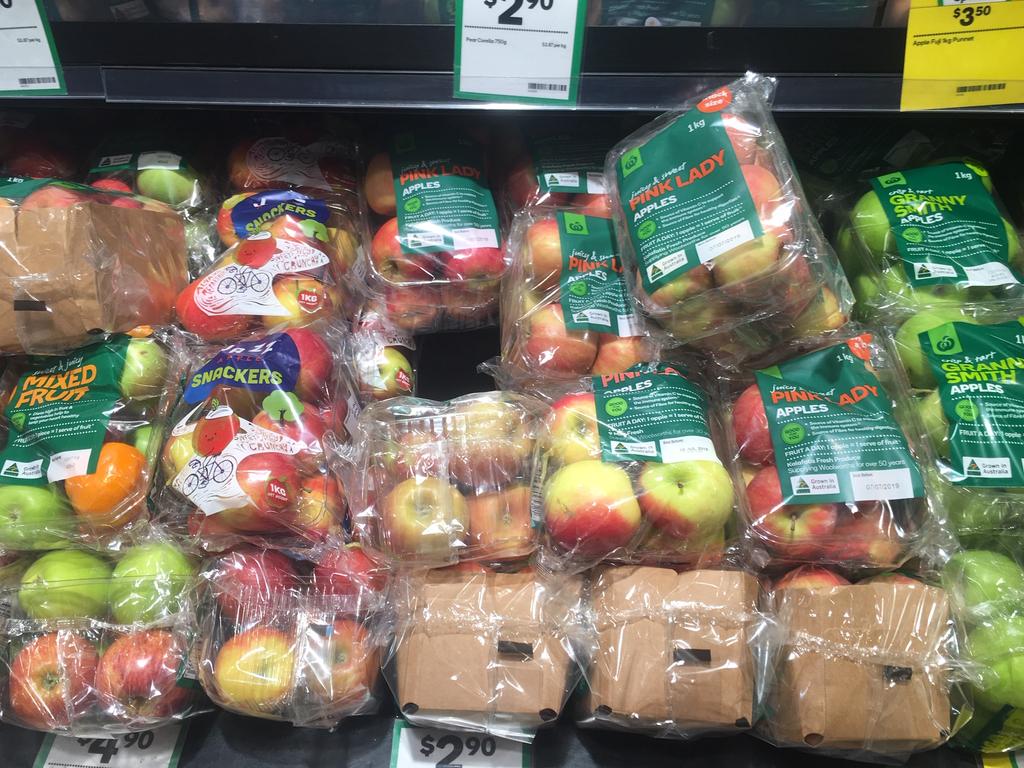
[721,327,936,572]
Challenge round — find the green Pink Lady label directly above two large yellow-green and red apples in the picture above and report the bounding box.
[593,364,721,464]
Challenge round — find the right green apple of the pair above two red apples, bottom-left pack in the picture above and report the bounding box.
[110,542,195,624]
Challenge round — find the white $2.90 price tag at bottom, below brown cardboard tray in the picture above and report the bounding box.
[391,720,530,768]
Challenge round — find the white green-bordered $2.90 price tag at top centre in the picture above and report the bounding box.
[455,0,587,104]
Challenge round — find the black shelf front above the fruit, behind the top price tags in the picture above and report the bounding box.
[6,23,1024,113]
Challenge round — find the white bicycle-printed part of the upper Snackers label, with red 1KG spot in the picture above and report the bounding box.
[188,232,331,317]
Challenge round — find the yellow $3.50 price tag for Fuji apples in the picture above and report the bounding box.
[900,0,1024,111]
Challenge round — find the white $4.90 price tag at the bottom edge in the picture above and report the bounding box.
[34,723,188,768]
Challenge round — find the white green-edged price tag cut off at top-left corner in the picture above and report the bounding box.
[0,0,68,96]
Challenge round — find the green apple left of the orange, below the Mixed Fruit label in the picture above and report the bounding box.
[0,485,76,550]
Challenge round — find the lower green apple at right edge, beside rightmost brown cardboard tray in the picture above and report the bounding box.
[968,615,1024,710]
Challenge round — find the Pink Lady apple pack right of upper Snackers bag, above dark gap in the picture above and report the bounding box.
[365,131,506,333]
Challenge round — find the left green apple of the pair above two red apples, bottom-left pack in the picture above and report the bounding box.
[17,550,111,618]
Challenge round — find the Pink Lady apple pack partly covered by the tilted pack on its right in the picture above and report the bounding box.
[502,207,660,381]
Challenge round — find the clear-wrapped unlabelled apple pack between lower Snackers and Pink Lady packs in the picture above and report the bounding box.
[351,392,547,567]
